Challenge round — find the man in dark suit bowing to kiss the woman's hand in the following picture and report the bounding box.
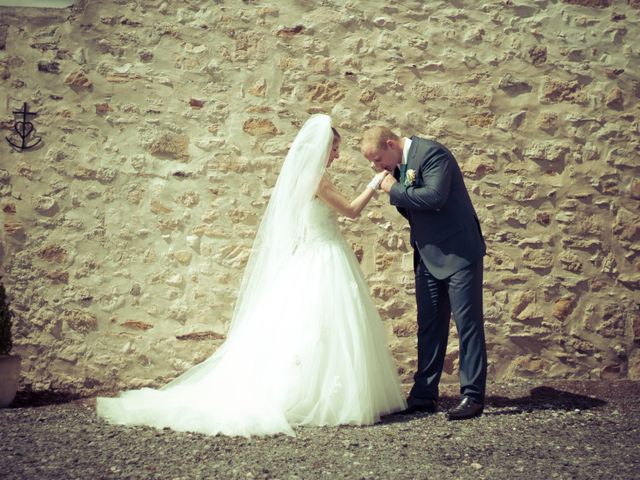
[361,127,487,420]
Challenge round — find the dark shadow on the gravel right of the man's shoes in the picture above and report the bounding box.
[485,386,607,415]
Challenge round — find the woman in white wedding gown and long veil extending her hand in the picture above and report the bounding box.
[97,115,406,436]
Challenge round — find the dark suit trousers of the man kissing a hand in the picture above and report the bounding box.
[410,250,487,403]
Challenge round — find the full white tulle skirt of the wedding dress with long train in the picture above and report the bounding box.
[97,237,406,436]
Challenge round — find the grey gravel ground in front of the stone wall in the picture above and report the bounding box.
[0,381,640,480]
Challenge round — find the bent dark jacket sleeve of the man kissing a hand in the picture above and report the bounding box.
[389,149,452,210]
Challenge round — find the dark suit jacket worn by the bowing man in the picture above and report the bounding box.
[390,136,486,279]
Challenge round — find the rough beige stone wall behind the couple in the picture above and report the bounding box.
[0,0,640,391]
